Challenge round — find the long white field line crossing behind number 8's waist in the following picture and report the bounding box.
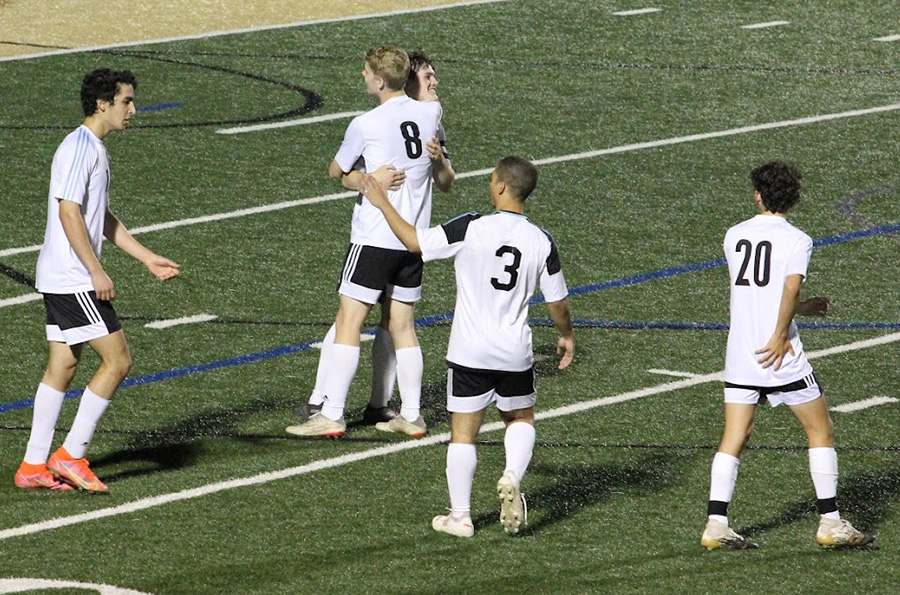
[0,103,900,274]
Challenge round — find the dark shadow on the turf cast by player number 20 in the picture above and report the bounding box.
[737,469,900,537]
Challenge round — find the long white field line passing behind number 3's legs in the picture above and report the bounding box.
[0,333,900,541]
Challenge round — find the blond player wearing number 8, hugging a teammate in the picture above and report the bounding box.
[286,46,442,437]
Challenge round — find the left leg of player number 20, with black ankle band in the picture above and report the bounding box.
[700,388,760,550]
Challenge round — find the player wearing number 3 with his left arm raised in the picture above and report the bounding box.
[362,157,575,537]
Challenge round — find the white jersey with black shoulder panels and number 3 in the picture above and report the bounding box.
[417,211,568,372]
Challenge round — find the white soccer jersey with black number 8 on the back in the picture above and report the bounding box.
[334,95,442,250]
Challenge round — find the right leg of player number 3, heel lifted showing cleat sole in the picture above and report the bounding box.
[497,369,537,534]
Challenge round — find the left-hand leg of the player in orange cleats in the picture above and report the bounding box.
[15,341,82,490]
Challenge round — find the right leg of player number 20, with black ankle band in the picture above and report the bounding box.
[785,386,874,547]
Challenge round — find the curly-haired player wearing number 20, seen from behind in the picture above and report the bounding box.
[701,161,873,550]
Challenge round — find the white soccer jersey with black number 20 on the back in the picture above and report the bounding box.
[724,215,812,387]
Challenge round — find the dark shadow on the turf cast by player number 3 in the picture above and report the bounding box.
[473,452,680,537]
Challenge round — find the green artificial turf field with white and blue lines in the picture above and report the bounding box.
[0,0,900,595]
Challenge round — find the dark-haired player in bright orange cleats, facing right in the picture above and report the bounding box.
[15,68,179,493]
